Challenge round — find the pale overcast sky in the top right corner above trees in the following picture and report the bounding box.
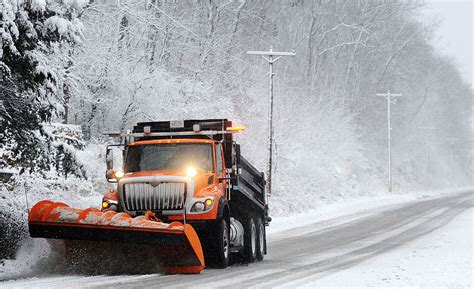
[424,0,474,85]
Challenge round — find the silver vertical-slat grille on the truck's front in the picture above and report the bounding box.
[123,182,186,211]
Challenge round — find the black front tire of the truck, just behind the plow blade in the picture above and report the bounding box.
[205,219,230,269]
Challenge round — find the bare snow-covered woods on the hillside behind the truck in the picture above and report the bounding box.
[70,0,472,194]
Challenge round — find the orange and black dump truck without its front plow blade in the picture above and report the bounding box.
[102,119,270,268]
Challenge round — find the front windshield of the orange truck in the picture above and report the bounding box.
[125,143,212,172]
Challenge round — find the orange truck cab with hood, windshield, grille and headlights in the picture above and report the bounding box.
[102,139,228,221]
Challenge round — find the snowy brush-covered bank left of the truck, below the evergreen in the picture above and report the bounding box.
[0,144,108,272]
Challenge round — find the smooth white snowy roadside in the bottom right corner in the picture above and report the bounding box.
[307,209,474,289]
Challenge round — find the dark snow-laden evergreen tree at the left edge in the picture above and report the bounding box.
[0,0,87,175]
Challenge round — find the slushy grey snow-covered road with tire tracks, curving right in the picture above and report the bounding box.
[0,192,473,288]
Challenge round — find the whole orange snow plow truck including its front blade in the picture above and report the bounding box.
[28,119,271,273]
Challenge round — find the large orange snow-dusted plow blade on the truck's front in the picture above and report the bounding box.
[28,201,205,274]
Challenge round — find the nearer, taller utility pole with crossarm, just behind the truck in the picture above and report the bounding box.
[247,47,296,202]
